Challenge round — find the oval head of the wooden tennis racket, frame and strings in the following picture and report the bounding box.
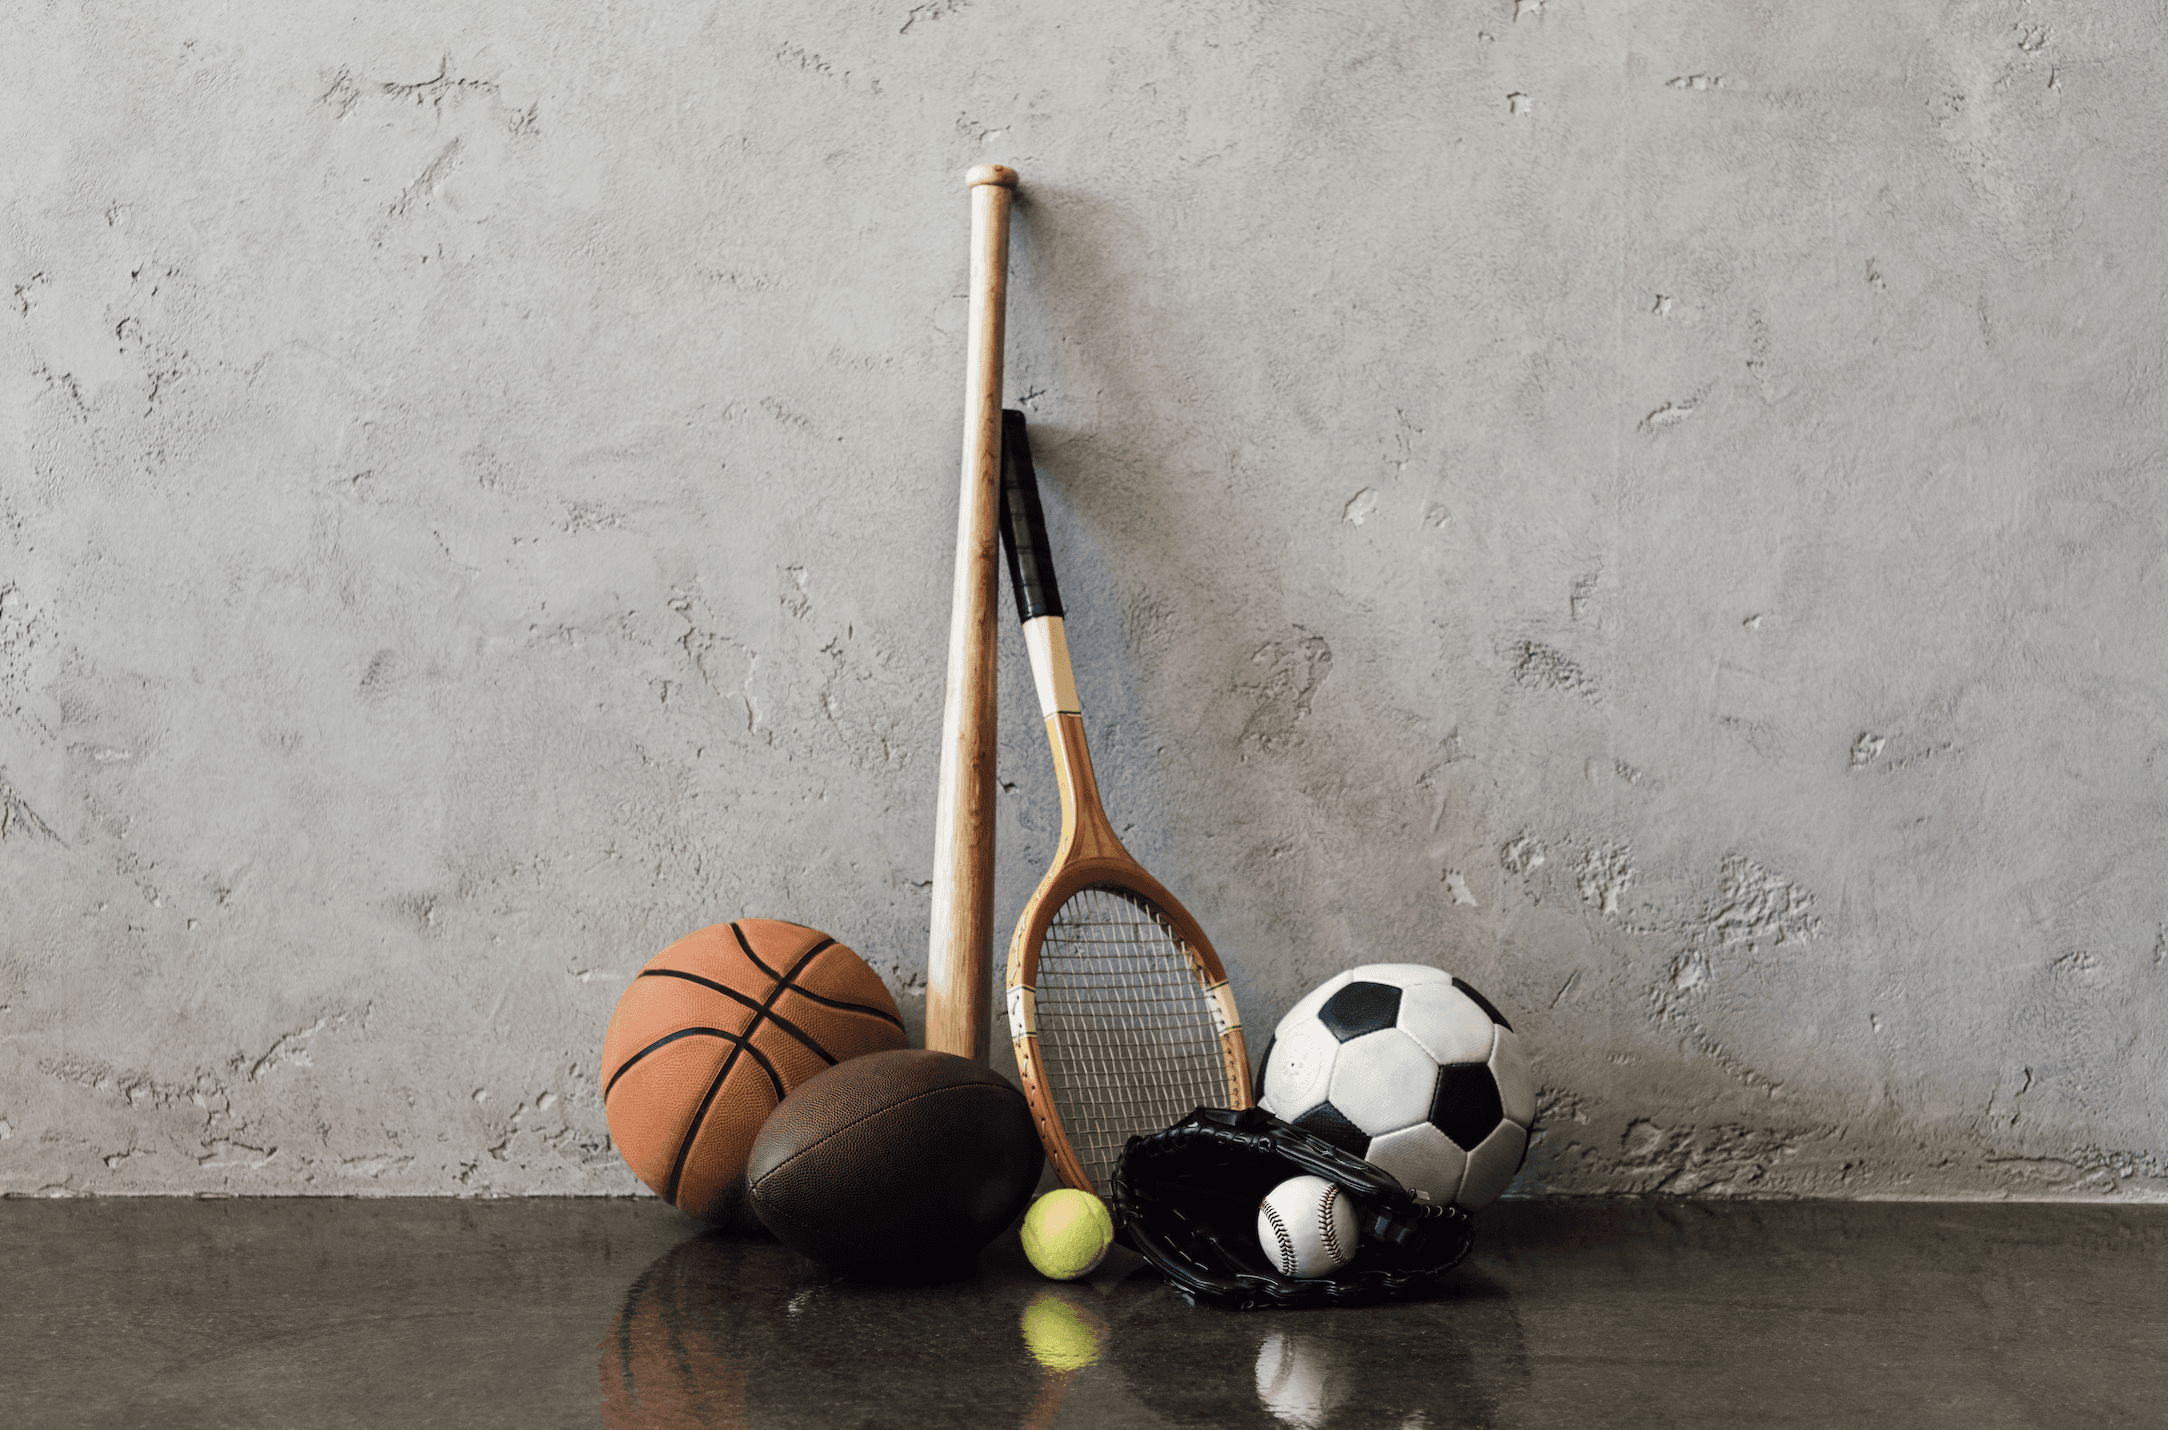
[1008,858,1253,1196]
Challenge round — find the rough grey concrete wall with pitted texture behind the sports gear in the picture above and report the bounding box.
[0,0,2168,1196]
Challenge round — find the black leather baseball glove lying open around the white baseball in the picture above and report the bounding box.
[1114,1107,1474,1311]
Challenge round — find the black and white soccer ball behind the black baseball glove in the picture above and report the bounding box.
[1257,964,1535,1211]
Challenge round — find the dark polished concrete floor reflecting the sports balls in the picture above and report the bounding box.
[0,1200,2168,1430]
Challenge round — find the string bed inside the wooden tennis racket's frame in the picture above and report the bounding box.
[1034,884,1231,1194]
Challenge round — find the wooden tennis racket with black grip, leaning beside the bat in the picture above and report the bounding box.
[1002,412,1251,1196]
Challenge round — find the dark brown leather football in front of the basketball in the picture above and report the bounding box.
[746,1049,1045,1281]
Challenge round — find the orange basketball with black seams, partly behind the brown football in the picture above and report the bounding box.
[603,919,904,1222]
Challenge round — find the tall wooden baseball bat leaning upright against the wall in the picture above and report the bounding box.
[926,165,1017,1062]
